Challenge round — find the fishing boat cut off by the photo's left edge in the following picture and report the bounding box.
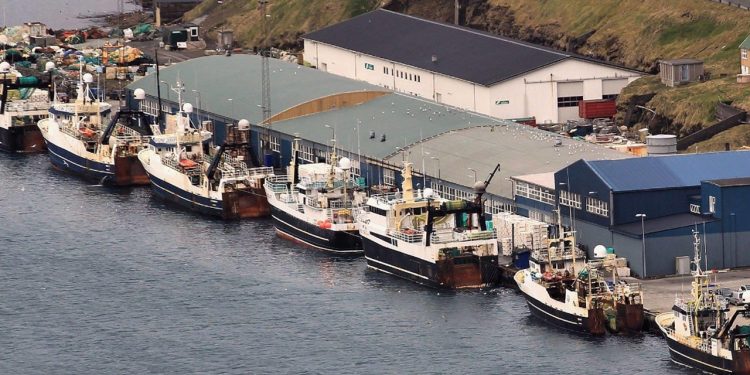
[0,62,54,153]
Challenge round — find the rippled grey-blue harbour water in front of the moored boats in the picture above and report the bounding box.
[0,154,704,375]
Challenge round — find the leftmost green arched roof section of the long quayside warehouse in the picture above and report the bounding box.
[127,54,384,124]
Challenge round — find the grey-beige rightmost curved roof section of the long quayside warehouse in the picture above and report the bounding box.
[388,121,632,198]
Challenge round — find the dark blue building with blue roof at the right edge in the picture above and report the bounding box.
[554,151,750,277]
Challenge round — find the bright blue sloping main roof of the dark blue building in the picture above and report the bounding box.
[586,151,750,191]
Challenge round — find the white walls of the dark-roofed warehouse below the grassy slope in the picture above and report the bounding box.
[304,40,642,123]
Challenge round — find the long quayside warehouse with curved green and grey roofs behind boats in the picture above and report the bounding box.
[128,54,628,217]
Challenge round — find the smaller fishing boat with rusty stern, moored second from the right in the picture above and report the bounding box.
[513,220,643,335]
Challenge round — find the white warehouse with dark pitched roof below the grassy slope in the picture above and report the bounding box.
[303,9,644,123]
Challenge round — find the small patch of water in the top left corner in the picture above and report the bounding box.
[0,0,140,29]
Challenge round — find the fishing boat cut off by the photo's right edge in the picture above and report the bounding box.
[656,231,750,374]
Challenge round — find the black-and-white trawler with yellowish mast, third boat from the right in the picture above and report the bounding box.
[359,162,500,289]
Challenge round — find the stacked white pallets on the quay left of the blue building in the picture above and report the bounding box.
[492,212,548,256]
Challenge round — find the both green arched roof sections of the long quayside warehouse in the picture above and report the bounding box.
[128,55,502,159]
